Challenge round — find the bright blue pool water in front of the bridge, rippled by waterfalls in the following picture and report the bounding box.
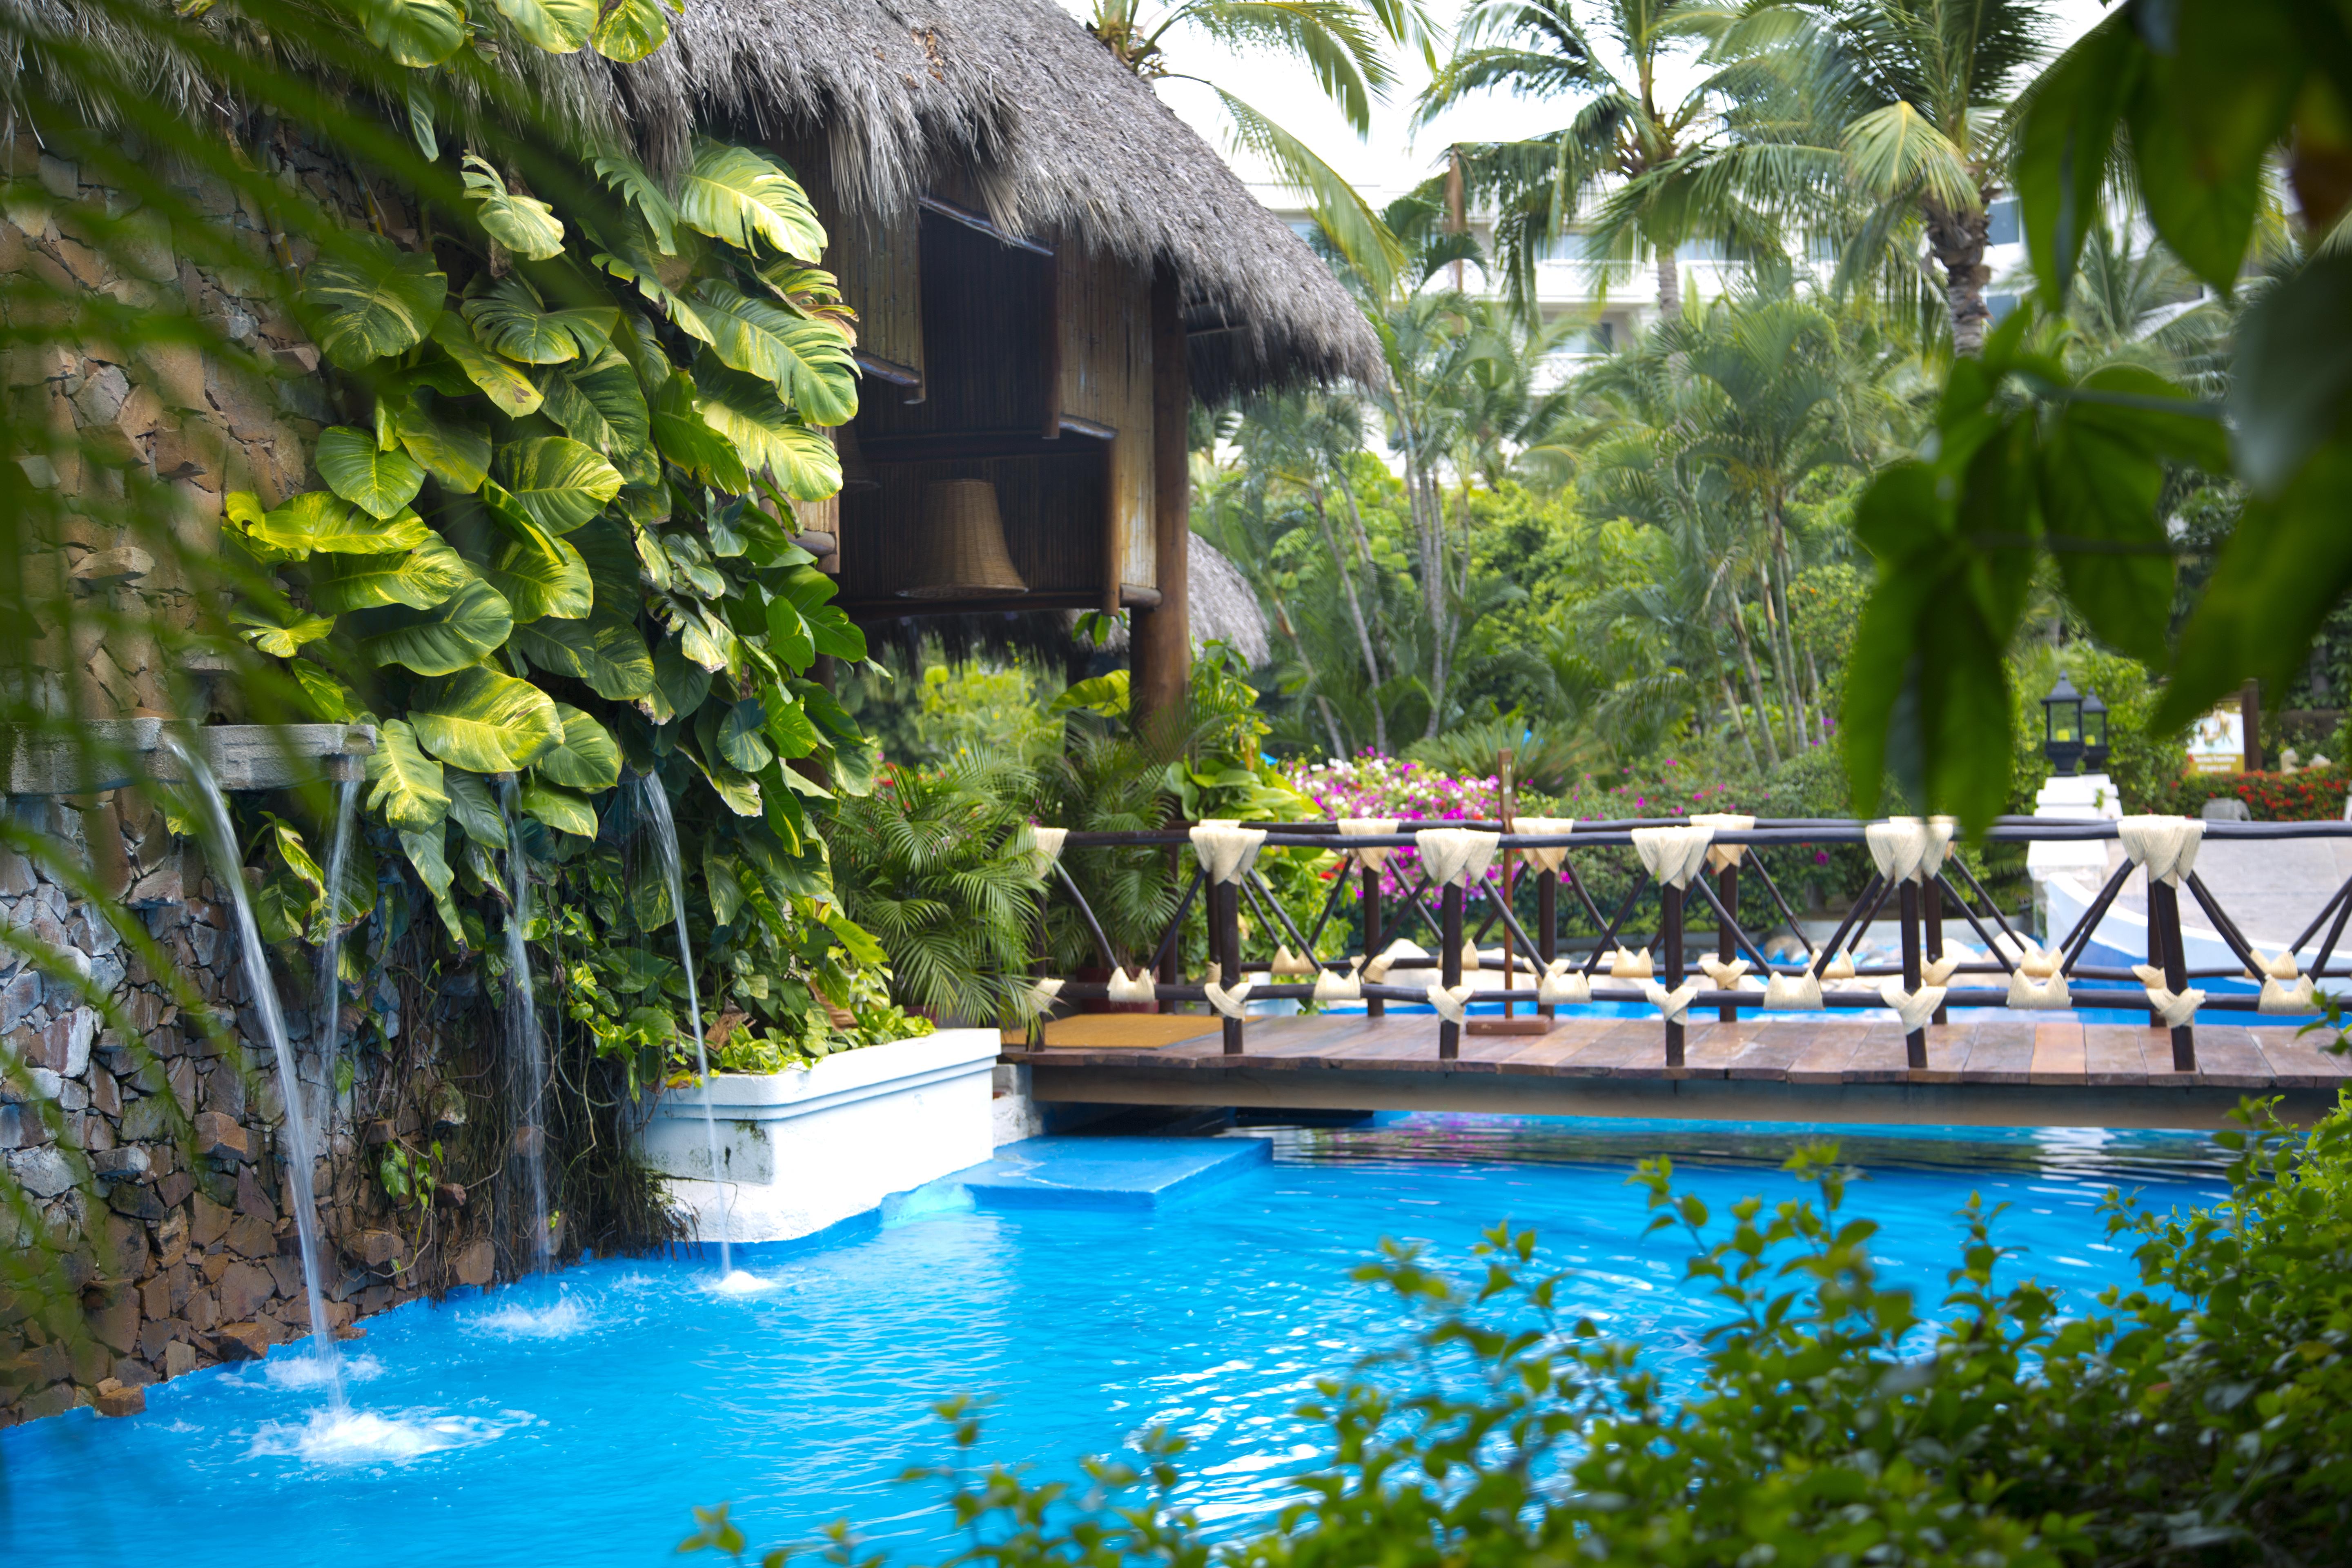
[0,1114,2220,1568]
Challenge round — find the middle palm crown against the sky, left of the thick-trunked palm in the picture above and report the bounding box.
[1416,0,1802,315]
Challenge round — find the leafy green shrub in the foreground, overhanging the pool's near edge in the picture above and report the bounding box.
[684,1102,2352,1568]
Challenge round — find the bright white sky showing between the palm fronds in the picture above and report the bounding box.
[1061,0,2105,207]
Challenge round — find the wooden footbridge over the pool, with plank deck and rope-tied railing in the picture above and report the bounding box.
[1004,816,2352,1126]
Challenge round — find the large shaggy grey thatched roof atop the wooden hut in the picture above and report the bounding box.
[611,0,1378,395]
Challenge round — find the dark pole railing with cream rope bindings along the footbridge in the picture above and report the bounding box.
[1033,816,2352,1072]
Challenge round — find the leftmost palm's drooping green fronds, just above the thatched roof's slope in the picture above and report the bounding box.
[1087,0,1430,273]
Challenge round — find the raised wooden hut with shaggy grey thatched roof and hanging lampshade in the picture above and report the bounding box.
[595,0,1378,708]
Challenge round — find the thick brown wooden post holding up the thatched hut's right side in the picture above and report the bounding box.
[1134,268,1195,743]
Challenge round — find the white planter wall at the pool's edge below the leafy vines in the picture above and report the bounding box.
[642,1030,1002,1241]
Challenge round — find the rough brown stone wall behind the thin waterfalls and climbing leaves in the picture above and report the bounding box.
[0,136,503,1425]
